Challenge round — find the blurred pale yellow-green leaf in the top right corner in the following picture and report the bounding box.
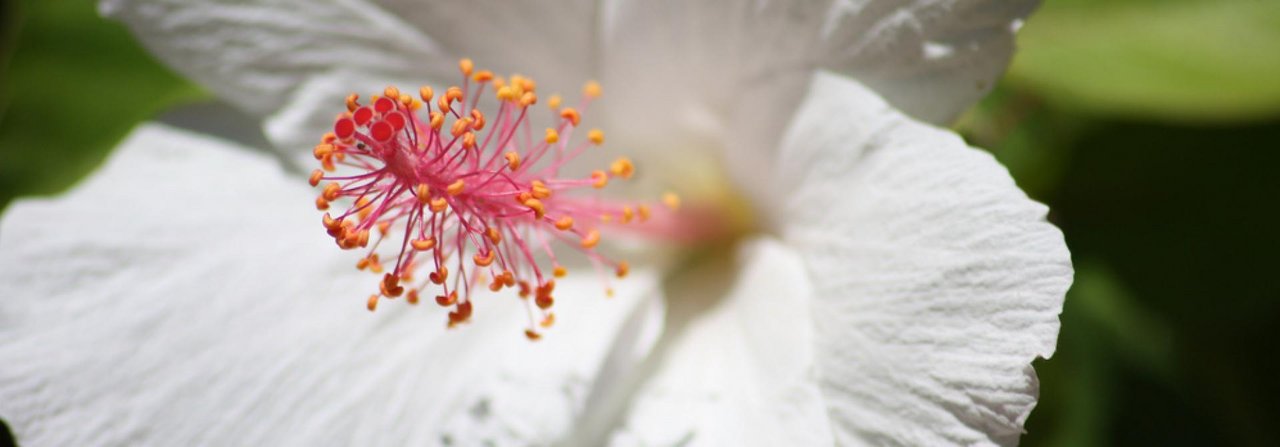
[1009,0,1280,122]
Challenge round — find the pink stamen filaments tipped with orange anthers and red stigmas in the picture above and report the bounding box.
[310,59,675,339]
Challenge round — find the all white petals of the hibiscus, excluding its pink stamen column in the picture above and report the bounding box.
[0,0,1071,446]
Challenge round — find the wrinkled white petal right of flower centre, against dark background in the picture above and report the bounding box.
[777,74,1071,446]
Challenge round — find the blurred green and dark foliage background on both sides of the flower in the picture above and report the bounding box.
[0,0,1280,446]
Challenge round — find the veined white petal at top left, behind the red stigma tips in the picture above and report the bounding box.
[101,0,461,152]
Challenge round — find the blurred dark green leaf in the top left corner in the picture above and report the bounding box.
[0,0,206,206]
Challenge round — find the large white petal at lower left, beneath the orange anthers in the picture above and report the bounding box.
[0,126,653,446]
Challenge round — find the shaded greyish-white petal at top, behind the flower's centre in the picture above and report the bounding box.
[602,0,1038,213]
